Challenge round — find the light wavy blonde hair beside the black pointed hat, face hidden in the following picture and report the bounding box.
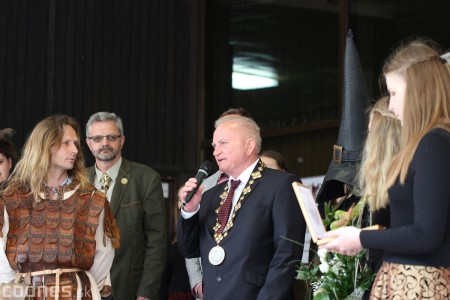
[358,97,402,211]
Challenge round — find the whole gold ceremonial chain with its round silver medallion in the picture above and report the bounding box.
[208,160,265,266]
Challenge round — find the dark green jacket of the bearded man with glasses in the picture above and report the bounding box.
[88,158,167,300]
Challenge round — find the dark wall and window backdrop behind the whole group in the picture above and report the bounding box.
[0,0,450,196]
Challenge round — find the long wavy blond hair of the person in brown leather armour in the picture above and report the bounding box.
[5,115,89,199]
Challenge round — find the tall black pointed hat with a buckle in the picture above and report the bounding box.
[317,30,369,202]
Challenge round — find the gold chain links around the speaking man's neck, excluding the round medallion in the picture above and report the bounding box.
[213,160,265,245]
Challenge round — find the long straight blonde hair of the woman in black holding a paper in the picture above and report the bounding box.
[383,39,450,187]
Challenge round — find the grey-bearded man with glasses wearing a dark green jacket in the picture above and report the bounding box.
[86,112,167,300]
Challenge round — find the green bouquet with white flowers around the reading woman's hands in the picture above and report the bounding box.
[296,198,375,300]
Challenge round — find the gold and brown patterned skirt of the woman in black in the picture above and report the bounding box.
[370,262,450,300]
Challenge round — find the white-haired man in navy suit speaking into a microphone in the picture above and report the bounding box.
[177,115,306,300]
